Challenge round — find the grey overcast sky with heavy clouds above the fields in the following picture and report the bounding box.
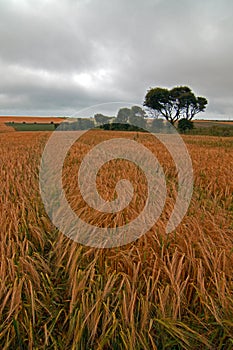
[0,0,233,119]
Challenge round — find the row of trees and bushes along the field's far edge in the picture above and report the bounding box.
[59,86,208,132]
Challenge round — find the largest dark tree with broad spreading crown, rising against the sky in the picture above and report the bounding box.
[144,86,208,125]
